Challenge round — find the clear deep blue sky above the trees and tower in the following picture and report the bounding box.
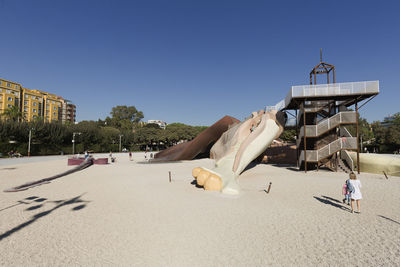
[0,0,400,125]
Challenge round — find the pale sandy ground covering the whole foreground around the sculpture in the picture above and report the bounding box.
[0,154,400,266]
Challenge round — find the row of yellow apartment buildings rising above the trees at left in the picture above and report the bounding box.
[0,79,76,123]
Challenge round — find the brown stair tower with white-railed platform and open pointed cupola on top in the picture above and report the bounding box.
[286,49,379,172]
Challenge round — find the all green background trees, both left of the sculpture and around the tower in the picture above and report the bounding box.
[0,103,400,156]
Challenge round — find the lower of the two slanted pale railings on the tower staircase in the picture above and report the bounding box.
[299,137,357,162]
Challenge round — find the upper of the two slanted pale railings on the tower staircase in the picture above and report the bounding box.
[296,111,357,146]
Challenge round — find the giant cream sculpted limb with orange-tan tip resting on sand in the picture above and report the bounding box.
[192,110,285,194]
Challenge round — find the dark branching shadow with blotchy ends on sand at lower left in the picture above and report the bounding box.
[0,194,90,241]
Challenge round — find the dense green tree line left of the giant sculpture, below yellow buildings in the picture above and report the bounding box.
[0,106,207,156]
